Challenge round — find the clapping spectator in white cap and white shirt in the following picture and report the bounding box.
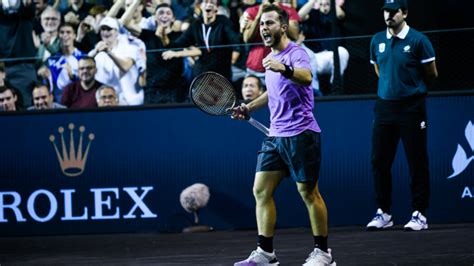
[89,17,144,105]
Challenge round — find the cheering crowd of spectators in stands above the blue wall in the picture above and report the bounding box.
[0,0,349,110]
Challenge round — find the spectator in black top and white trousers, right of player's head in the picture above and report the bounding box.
[298,0,349,86]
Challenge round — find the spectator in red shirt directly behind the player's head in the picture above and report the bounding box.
[240,0,300,84]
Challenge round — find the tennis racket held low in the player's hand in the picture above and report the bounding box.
[189,72,269,136]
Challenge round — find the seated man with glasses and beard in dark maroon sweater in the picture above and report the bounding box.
[61,56,102,108]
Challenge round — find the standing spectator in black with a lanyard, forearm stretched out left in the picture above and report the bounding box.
[163,0,240,80]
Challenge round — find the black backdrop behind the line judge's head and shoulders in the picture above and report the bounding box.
[334,0,474,94]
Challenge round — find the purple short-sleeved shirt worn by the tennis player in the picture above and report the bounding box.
[265,42,321,137]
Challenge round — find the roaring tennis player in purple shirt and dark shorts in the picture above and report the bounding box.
[232,5,336,266]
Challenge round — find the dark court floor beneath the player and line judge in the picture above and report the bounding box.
[0,224,474,266]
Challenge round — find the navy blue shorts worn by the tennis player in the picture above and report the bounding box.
[256,130,321,183]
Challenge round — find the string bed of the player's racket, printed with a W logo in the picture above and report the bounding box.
[191,74,236,115]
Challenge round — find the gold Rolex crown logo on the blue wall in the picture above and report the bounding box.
[49,123,94,176]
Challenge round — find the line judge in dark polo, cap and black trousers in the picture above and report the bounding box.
[367,0,438,231]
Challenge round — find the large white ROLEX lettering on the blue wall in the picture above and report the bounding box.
[0,186,158,223]
